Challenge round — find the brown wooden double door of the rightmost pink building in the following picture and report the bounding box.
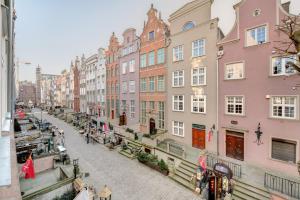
[226,134,244,160]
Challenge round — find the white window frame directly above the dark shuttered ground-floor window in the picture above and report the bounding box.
[270,95,299,120]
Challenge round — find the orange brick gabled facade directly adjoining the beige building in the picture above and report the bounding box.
[140,5,169,134]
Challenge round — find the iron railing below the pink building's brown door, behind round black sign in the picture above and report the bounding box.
[206,155,242,178]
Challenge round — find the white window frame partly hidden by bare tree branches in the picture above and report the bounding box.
[271,56,297,76]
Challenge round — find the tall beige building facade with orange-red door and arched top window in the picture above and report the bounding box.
[167,0,221,156]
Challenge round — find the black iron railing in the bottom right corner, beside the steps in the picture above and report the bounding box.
[264,173,300,199]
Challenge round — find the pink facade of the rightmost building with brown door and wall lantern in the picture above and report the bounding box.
[218,0,300,182]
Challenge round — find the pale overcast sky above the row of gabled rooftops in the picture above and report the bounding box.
[15,0,300,81]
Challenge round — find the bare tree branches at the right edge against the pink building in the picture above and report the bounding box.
[274,15,300,72]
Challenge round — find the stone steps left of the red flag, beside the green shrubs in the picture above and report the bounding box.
[169,161,197,191]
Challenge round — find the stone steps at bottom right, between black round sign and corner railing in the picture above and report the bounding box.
[233,179,271,200]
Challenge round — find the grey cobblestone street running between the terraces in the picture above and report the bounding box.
[35,113,200,200]
